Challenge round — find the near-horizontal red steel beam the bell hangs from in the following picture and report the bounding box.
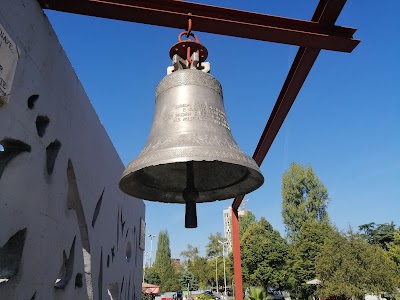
[38,0,359,52]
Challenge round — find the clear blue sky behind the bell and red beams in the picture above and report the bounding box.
[46,0,400,258]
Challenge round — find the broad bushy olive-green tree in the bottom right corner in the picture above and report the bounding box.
[316,233,398,299]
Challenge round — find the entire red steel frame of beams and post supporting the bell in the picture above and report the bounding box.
[37,0,360,300]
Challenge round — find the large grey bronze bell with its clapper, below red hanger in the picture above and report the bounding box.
[119,29,264,228]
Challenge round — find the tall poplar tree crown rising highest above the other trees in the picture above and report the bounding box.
[282,163,329,239]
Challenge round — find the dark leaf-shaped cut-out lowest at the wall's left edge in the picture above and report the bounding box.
[0,228,27,283]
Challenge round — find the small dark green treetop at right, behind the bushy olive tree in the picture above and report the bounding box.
[358,222,396,250]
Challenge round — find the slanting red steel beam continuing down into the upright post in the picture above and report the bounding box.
[232,0,358,300]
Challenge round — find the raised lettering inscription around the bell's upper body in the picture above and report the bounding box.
[164,103,230,130]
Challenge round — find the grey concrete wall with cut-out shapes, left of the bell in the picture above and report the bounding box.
[0,0,145,300]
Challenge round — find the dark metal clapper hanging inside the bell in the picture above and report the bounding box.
[182,161,199,228]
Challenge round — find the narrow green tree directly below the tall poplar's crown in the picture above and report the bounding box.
[289,220,335,299]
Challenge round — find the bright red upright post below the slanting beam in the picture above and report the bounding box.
[232,209,244,300]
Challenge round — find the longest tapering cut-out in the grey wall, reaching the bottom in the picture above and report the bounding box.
[67,159,93,298]
